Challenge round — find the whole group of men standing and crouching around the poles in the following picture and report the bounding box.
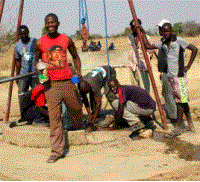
[15,13,197,163]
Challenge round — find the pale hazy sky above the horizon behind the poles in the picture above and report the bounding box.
[0,0,200,38]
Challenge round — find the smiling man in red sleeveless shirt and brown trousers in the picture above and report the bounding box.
[35,13,83,163]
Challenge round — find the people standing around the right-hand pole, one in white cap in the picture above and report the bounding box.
[129,19,198,137]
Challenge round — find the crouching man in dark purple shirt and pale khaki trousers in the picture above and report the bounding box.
[108,78,156,132]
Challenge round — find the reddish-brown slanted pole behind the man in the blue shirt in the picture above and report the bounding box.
[5,0,24,122]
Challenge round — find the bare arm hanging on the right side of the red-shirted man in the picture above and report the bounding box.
[68,37,82,78]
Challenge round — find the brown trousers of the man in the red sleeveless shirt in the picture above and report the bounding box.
[45,80,83,156]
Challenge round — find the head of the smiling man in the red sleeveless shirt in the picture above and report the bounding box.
[45,13,60,36]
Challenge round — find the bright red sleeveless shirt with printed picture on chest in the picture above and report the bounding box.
[40,34,73,80]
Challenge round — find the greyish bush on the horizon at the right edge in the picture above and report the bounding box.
[183,21,200,37]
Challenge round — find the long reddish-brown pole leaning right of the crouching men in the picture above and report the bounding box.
[128,0,167,129]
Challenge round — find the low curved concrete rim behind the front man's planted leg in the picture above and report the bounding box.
[3,124,131,148]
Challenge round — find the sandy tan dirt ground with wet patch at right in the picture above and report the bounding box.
[0,37,200,181]
